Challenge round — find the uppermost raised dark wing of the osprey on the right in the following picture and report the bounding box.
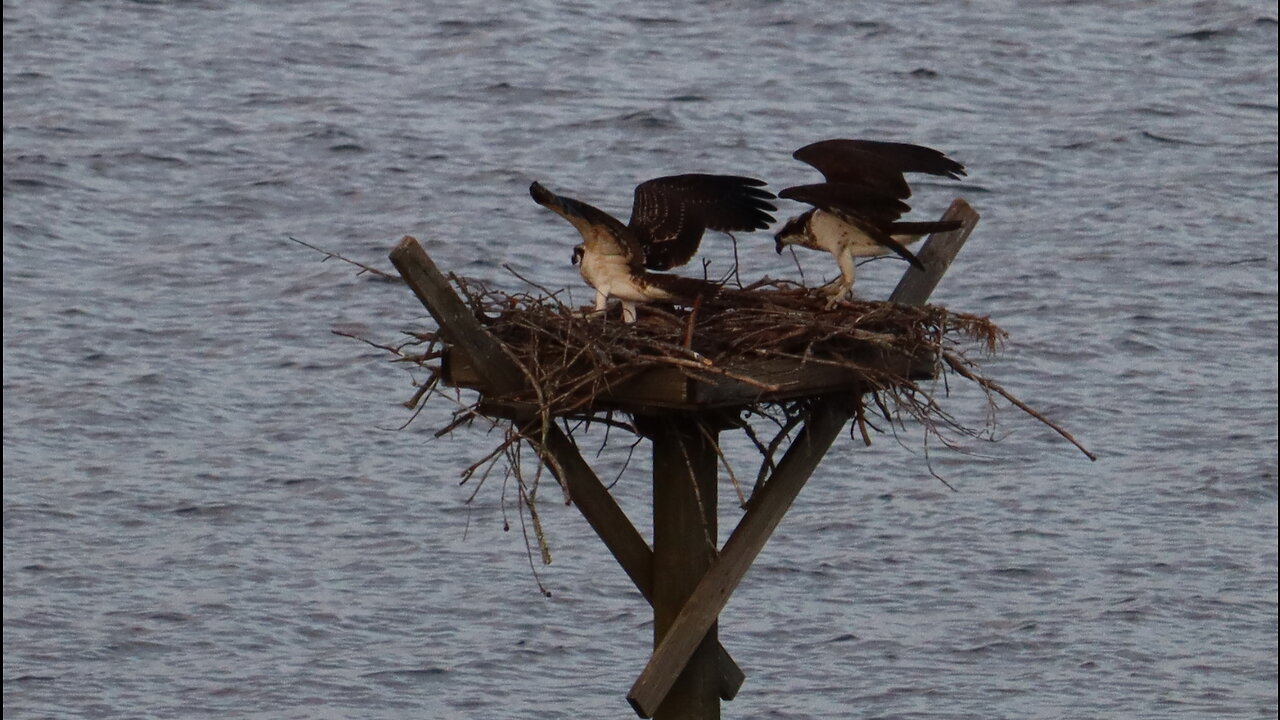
[792,138,965,200]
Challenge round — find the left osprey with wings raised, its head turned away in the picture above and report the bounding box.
[529,174,777,323]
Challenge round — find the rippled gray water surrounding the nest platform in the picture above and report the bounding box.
[4,0,1277,719]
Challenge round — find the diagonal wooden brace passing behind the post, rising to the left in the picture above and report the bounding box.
[390,236,746,700]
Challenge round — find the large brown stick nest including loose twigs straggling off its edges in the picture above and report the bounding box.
[380,277,1059,484]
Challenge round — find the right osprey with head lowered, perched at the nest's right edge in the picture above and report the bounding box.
[773,140,965,302]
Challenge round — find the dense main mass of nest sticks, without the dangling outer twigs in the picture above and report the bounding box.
[445,275,1005,418]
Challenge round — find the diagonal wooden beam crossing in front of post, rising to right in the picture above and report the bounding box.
[627,199,978,717]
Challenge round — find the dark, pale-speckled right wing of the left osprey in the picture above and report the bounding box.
[627,173,777,270]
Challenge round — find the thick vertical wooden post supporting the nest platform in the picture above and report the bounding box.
[645,414,721,720]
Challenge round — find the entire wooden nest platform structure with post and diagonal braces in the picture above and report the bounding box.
[390,200,978,720]
